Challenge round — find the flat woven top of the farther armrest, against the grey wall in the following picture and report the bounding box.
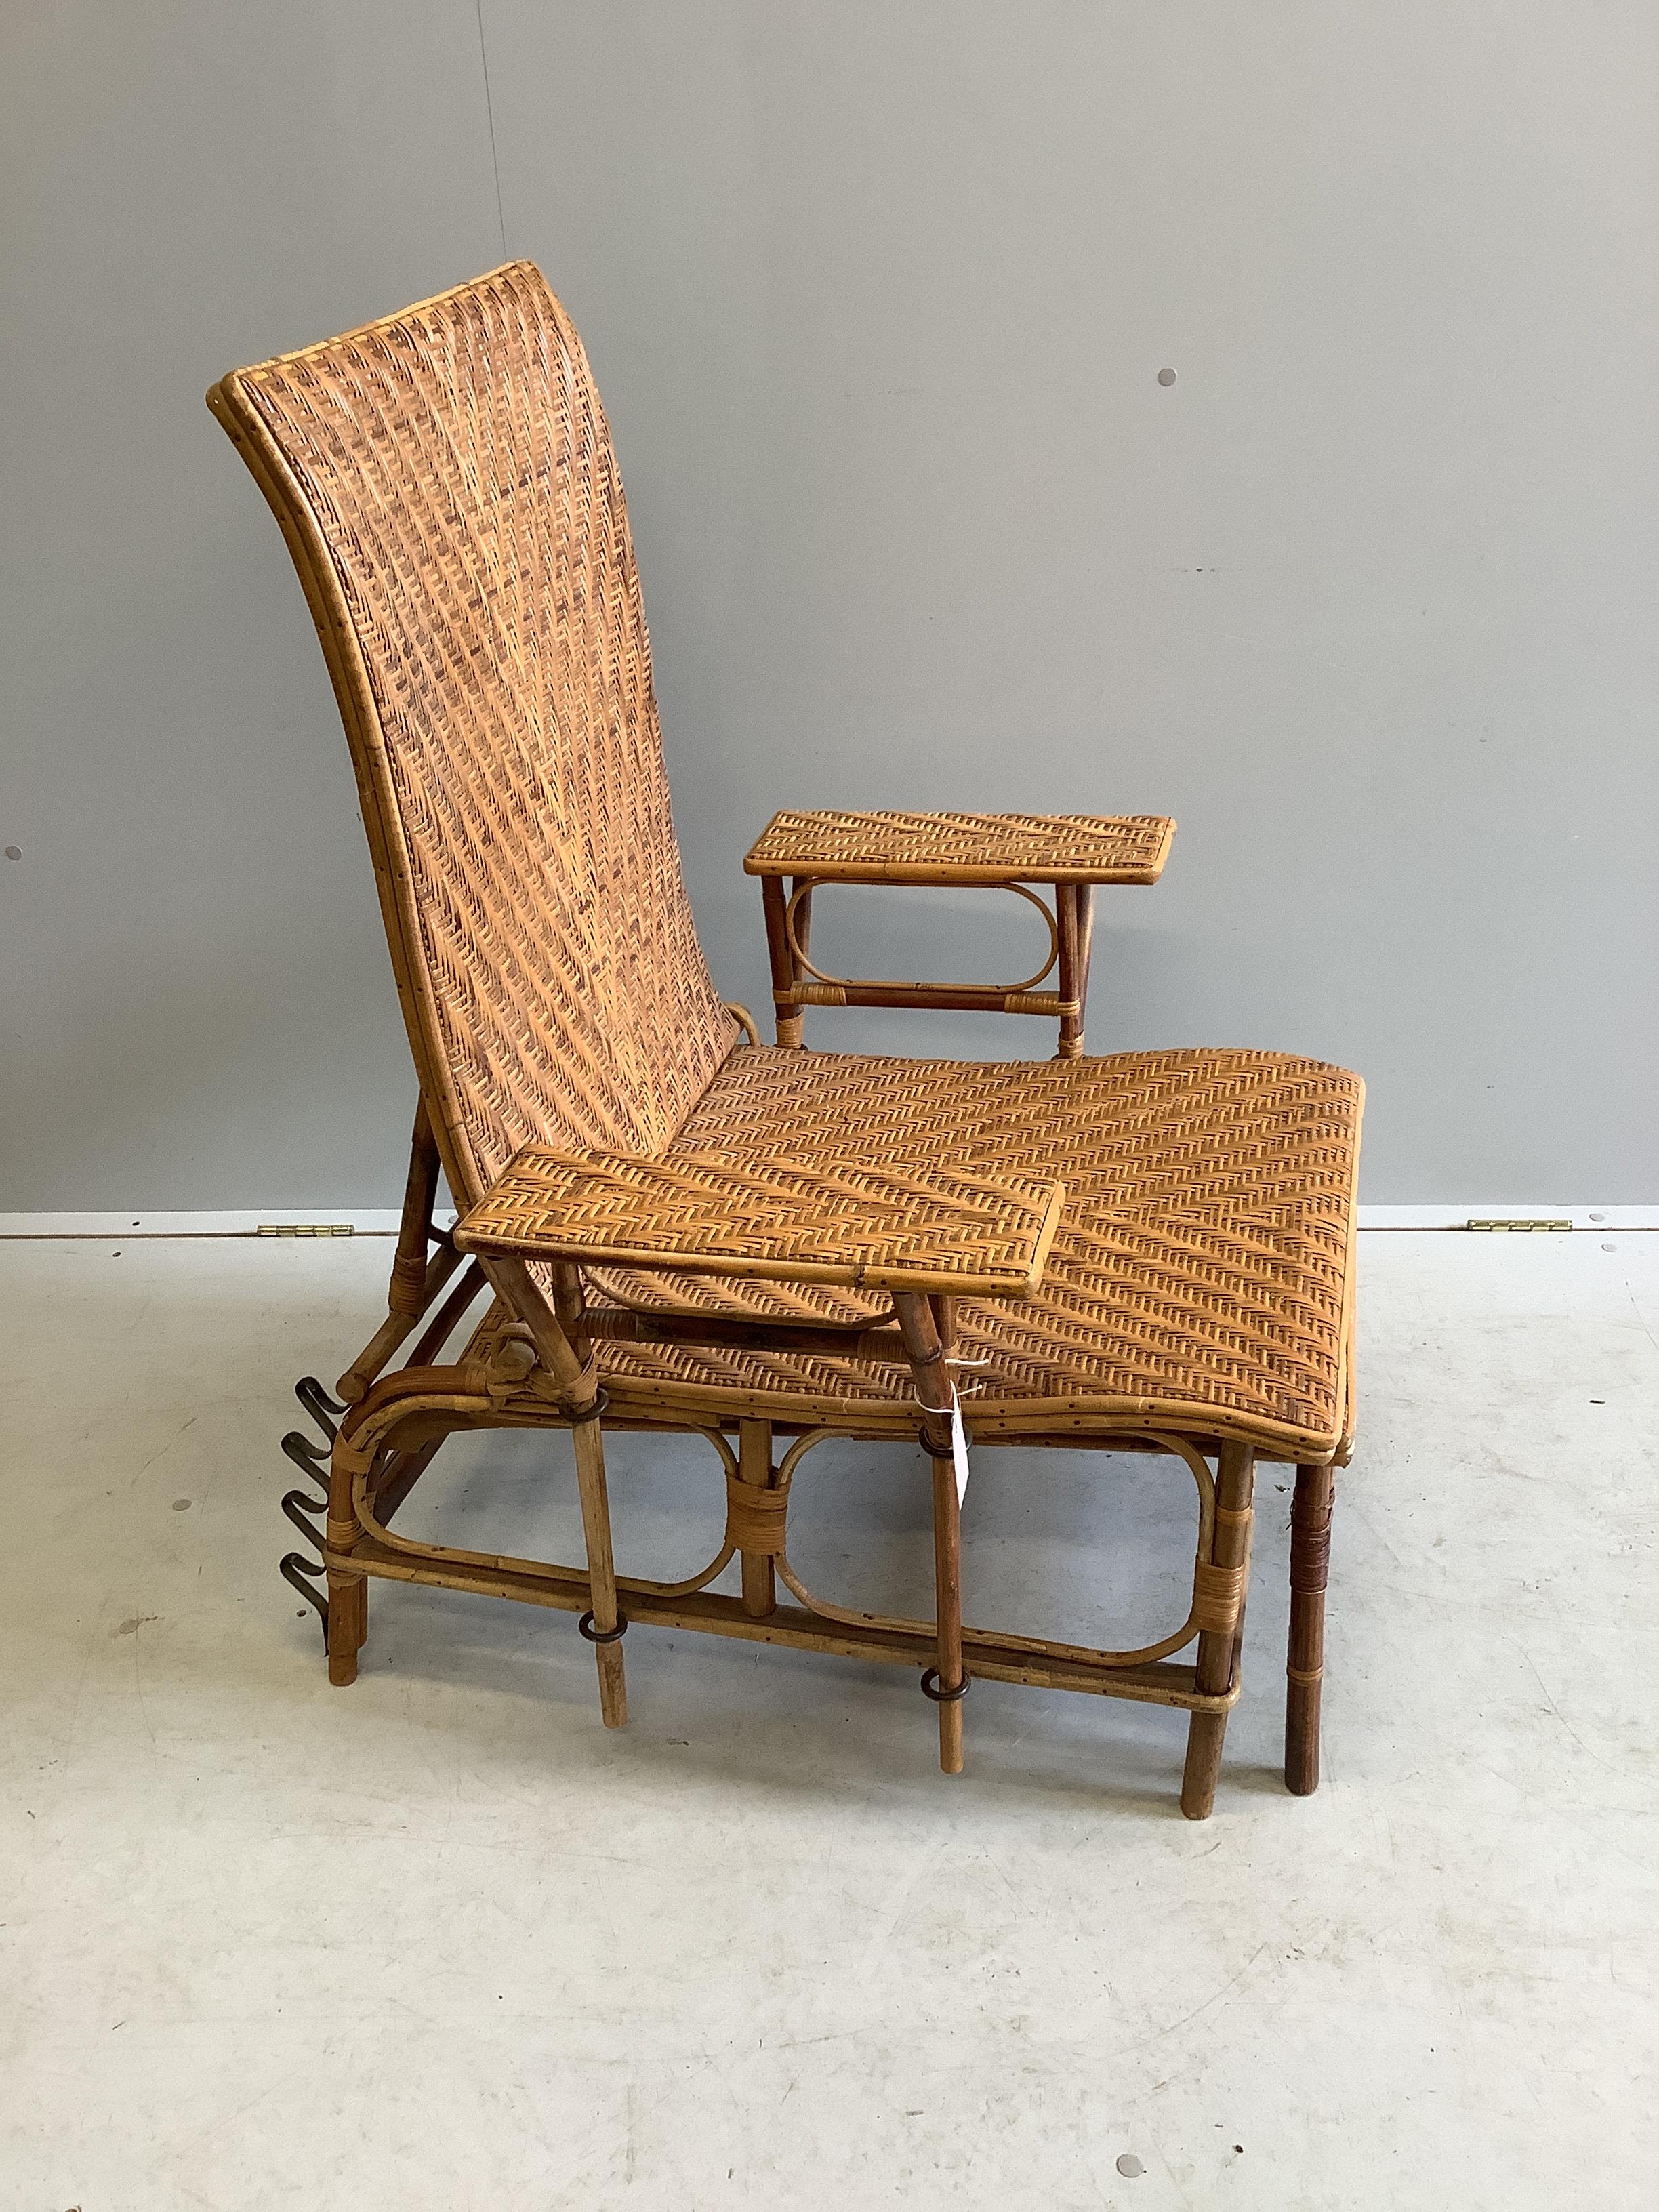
[743,812,1174,882]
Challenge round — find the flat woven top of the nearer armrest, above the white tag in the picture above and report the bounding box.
[455,1143,1064,1298]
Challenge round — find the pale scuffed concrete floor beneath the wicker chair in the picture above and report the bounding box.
[0,1234,1659,2212]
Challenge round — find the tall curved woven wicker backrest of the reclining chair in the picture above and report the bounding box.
[208,261,737,1206]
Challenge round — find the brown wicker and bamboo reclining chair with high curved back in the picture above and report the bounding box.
[208,263,1363,1818]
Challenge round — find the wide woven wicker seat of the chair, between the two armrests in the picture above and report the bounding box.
[593,1050,1363,1451]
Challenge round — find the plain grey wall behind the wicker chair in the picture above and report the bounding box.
[0,0,1659,1208]
